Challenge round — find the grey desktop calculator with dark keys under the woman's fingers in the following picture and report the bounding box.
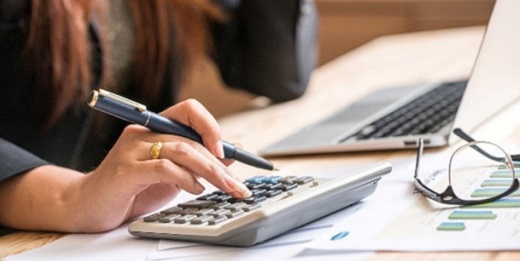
[128,162,392,246]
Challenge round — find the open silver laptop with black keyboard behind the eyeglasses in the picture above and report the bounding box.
[259,0,520,156]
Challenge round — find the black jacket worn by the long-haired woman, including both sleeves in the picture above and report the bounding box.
[0,0,317,181]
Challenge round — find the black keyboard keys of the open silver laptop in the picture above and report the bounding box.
[349,80,468,140]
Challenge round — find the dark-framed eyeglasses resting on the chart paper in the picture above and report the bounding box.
[414,128,520,205]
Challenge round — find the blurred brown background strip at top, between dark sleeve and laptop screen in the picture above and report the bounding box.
[315,0,495,64]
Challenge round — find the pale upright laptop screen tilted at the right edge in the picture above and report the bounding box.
[450,0,520,143]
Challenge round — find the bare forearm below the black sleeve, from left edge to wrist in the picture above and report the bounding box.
[0,165,85,232]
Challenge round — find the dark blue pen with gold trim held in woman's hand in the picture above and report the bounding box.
[88,89,275,170]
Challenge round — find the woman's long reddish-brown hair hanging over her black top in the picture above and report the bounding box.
[25,0,223,127]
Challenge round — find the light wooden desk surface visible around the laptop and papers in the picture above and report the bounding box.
[0,27,520,260]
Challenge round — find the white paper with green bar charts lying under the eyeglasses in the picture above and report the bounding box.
[307,145,520,251]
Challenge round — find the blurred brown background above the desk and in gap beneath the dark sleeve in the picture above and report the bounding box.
[181,0,495,118]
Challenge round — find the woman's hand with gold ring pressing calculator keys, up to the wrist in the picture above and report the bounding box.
[81,100,251,230]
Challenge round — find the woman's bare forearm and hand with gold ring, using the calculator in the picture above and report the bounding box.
[0,100,251,232]
